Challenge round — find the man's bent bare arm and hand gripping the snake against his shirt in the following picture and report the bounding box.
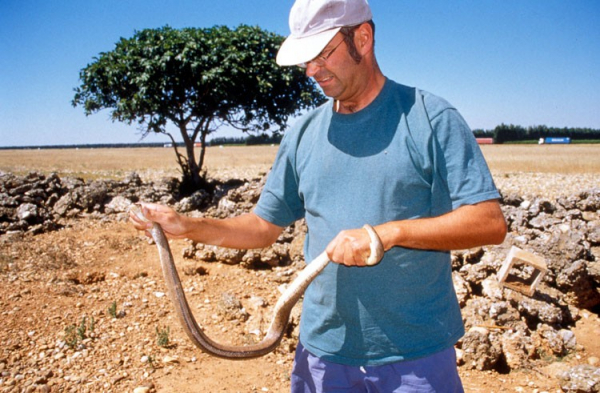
[327,200,507,266]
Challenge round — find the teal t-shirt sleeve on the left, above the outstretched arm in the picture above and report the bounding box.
[254,132,304,227]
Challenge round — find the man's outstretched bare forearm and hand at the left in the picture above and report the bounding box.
[129,203,284,249]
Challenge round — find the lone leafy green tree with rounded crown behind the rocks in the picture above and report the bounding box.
[72,25,325,188]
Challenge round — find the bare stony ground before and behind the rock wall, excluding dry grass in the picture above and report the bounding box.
[0,167,600,393]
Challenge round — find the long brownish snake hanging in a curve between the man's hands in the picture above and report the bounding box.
[130,205,384,360]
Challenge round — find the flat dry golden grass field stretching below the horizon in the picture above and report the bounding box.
[0,145,600,180]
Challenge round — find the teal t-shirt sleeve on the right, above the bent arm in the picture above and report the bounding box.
[431,102,500,209]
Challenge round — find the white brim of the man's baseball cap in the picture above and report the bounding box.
[277,27,341,66]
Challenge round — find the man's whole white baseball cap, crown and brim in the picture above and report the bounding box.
[277,0,373,66]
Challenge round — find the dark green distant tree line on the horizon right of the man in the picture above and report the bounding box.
[473,123,600,143]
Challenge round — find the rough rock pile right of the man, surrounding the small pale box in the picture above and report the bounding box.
[453,189,600,371]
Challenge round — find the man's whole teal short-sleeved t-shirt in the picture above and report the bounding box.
[255,80,500,366]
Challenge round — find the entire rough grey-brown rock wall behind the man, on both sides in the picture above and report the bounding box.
[0,173,600,372]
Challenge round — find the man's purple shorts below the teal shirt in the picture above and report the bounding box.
[291,343,464,393]
